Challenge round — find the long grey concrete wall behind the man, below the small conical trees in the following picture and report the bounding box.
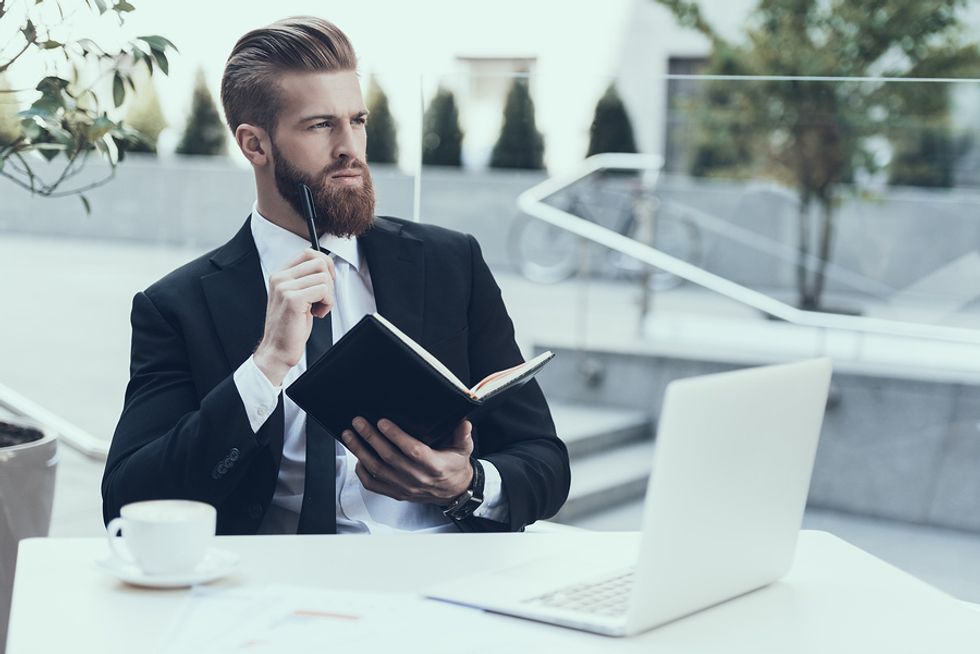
[0,157,980,312]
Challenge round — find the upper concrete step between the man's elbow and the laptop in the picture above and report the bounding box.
[550,402,653,462]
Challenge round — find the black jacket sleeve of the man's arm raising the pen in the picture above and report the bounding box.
[102,293,282,522]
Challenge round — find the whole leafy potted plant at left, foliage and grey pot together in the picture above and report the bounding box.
[0,0,176,652]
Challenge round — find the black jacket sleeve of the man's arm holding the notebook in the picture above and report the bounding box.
[462,236,571,531]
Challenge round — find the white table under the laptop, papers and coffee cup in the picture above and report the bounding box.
[7,531,980,654]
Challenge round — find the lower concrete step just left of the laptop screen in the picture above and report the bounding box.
[554,440,654,524]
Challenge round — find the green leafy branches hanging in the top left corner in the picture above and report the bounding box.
[0,0,176,211]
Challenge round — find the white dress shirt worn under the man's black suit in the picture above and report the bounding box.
[234,204,508,534]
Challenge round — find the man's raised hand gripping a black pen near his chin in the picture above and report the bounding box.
[254,250,337,386]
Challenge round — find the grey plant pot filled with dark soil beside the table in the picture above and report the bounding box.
[0,414,58,654]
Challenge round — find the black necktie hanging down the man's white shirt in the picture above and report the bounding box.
[298,314,337,534]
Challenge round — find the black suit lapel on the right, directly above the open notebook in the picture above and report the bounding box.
[358,216,425,343]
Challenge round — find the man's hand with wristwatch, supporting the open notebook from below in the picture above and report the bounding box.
[341,418,473,506]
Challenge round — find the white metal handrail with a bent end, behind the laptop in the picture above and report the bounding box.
[517,152,980,343]
